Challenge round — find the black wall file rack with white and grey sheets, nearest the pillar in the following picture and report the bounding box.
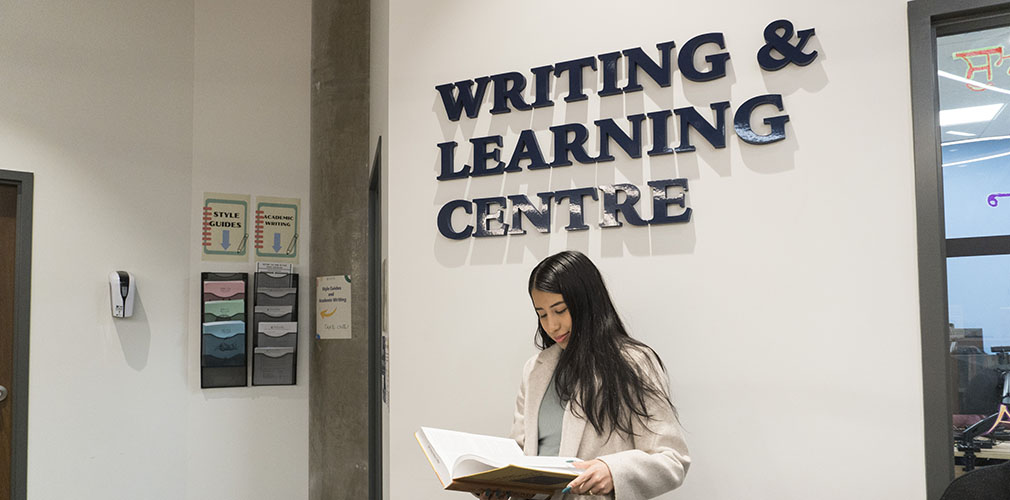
[253,273,298,386]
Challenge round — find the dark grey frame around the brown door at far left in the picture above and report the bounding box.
[0,170,34,500]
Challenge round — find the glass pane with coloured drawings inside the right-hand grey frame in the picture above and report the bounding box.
[936,18,1010,477]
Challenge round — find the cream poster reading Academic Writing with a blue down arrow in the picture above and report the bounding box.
[255,196,302,264]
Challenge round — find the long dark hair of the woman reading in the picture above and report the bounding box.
[529,251,676,435]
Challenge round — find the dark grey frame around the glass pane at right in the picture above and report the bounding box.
[908,0,1010,500]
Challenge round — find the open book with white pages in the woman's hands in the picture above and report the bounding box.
[414,427,582,498]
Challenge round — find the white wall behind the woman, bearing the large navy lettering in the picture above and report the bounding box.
[387,0,925,500]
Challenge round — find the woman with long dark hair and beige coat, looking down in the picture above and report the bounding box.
[481,252,690,500]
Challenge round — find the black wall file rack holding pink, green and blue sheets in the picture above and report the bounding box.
[200,273,248,389]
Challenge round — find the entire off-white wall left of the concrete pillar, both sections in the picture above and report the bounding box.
[0,0,310,500]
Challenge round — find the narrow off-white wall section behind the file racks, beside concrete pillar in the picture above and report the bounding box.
[186,0,315,500]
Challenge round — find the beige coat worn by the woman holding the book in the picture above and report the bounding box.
[511,344,691,500]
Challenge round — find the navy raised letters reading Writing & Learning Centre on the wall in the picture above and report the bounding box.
[435,19,817,239]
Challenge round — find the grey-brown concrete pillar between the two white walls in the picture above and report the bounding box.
[307,0,373,500]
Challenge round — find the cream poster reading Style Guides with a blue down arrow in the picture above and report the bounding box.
[200,193,249,262]
